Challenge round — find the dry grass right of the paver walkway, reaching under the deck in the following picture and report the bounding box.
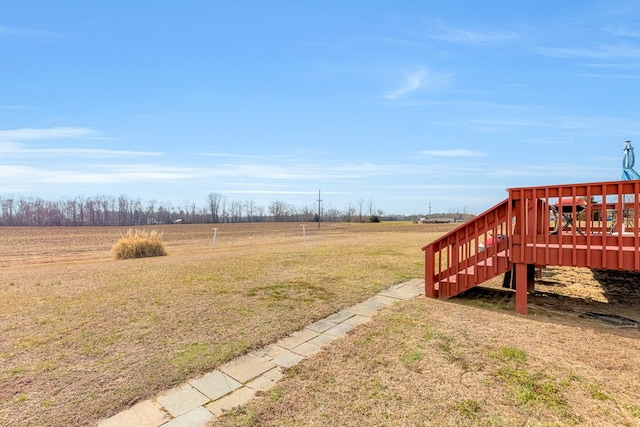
[209,267,640,427]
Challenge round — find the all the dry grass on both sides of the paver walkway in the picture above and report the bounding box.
[0,223,640,426]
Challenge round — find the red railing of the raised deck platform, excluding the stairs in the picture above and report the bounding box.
[508,181,640,271]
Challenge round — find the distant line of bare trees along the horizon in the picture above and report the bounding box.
[0,193,382,227]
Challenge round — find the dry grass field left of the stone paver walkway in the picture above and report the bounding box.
[0,223,443,426]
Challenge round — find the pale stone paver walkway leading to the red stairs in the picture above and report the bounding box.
[98,279,424,427]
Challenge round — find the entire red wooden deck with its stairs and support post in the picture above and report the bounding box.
[422,181,640,314]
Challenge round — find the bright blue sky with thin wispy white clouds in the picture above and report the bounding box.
[0,0,640,214]
